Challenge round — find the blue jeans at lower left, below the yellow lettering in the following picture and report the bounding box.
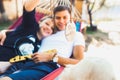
[2,61,58,80]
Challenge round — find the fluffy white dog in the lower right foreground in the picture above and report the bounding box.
[58,57,116,80]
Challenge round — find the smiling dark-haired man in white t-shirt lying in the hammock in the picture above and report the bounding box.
[39,6,85,66]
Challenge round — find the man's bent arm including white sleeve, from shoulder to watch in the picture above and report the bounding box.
[58,32,85,66]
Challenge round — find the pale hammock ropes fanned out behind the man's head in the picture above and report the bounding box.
[37,0,82,22]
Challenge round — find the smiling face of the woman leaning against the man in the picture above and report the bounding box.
[39,18,54,37]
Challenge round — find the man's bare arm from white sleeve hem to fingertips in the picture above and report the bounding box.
[32,45,84,66]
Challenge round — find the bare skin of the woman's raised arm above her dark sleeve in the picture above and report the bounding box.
[24,0,40,11]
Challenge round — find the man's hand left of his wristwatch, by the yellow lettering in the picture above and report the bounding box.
[32,52,54,63]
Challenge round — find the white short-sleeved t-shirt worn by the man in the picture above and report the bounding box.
[38,31,85,58]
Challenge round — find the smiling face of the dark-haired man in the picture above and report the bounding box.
[54,10,70,30]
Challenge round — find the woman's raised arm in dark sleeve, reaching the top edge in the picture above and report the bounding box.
[21,0,40,30]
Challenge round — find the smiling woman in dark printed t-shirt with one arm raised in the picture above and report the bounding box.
[0,0,54,61]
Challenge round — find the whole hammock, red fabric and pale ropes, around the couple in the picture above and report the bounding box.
[8,0,81,80]
